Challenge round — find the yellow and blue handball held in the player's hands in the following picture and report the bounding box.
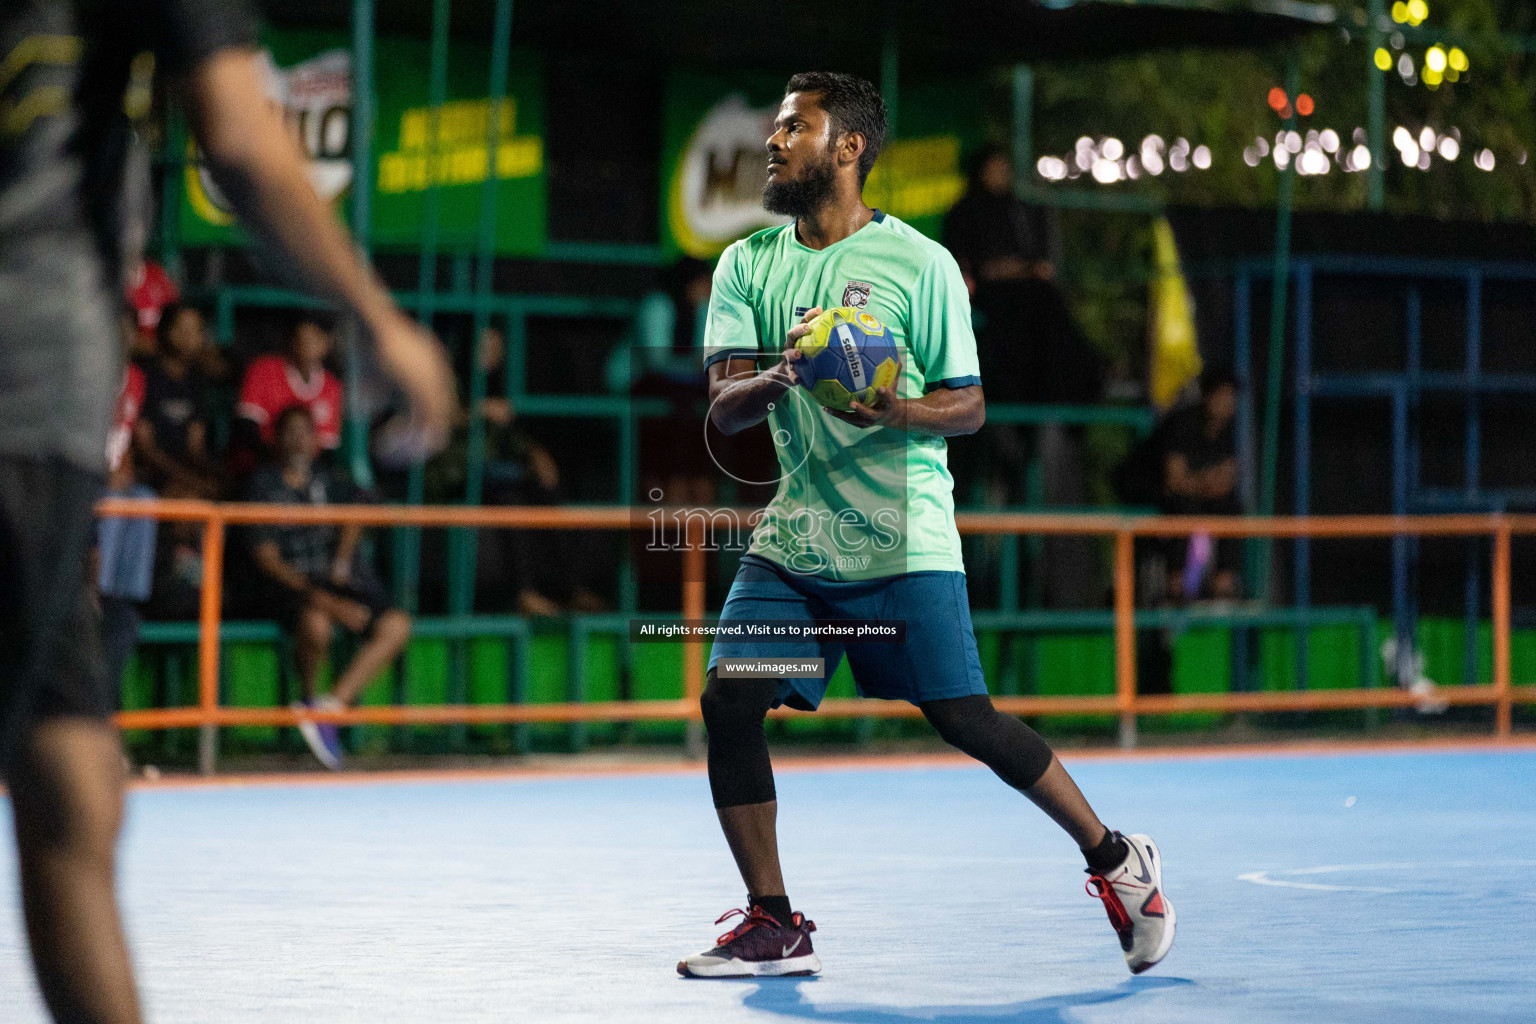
[794,306,902,413]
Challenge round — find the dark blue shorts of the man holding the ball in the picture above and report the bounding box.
[710,554,986,711]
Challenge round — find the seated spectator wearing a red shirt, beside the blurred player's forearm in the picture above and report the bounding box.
[230,313,343,476]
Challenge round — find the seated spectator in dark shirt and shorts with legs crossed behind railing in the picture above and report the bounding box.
[246,405,410,769]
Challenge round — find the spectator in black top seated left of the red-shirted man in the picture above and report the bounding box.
[134,302,218,497]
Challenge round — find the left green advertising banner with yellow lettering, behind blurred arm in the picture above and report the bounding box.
[181,29,545,255]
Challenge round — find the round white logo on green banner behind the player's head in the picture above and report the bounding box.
[667,92,790,259]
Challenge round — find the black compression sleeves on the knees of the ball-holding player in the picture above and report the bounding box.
[700,671,1052,808]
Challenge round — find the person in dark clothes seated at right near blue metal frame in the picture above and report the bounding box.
[1160,370,1243,600]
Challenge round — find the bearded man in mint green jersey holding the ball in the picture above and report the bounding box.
[677,72,1174,978]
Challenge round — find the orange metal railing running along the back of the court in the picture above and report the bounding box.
[98,499,1536,767]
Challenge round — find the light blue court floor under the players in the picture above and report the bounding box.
[0,749,1536,1024]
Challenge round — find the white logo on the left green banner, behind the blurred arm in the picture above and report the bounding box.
[186,49,352,226]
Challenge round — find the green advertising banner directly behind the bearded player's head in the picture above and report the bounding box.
[660,71,985,259]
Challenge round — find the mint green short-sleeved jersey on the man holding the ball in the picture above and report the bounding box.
[705,210,982,580]
